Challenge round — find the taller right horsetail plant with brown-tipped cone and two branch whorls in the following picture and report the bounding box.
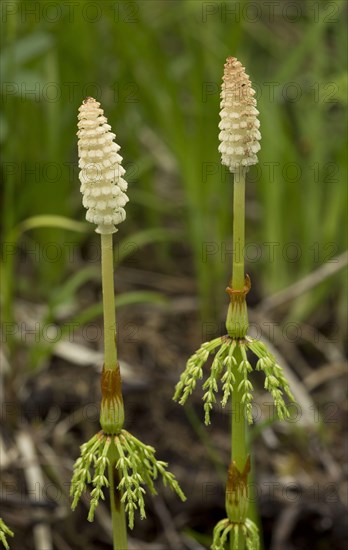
[174,57,294,550]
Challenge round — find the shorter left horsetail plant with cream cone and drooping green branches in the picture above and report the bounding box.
[70,97,186,550]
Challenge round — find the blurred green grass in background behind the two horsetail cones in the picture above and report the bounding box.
[0,0,347,336]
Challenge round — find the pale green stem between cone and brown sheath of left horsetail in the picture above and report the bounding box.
[101,234,117,370]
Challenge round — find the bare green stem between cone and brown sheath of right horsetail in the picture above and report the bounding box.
[232,168,245,290]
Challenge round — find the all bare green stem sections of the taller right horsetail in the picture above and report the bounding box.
[230,169,247,550]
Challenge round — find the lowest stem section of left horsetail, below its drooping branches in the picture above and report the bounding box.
[108,454,128,550]
